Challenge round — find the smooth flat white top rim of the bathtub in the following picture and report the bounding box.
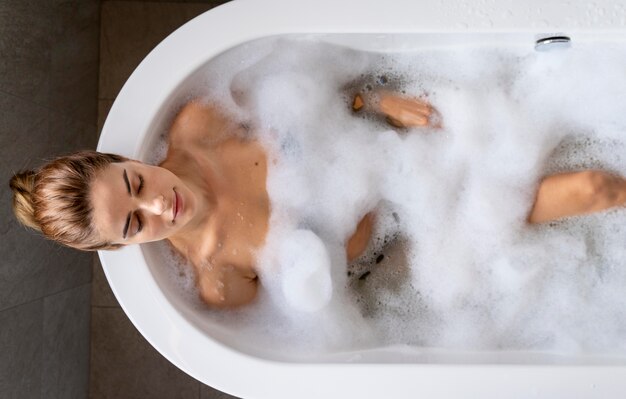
[98,0,626,398]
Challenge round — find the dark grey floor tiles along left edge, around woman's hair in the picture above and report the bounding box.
[0,0,100,399]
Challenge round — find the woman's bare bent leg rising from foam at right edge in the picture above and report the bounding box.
[528,171,626,223]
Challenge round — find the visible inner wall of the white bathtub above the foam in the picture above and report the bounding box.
[128,32,626,365]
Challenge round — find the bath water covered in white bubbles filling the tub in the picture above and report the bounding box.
[147,37,626,354]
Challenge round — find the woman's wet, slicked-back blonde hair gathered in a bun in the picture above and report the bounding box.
[9,151,128,251]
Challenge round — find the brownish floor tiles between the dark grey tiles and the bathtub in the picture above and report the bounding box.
[89,1,239,399]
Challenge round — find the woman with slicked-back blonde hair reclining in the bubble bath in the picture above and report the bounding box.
[10,92,626,307]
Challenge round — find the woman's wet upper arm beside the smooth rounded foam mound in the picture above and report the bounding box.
[198,265,259,308]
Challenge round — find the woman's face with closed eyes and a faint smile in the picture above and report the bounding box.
[91,161,198,245]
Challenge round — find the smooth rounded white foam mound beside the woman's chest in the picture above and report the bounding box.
[278,230,332,312]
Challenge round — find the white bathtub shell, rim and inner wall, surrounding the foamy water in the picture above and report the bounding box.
[98,0,626,399]
